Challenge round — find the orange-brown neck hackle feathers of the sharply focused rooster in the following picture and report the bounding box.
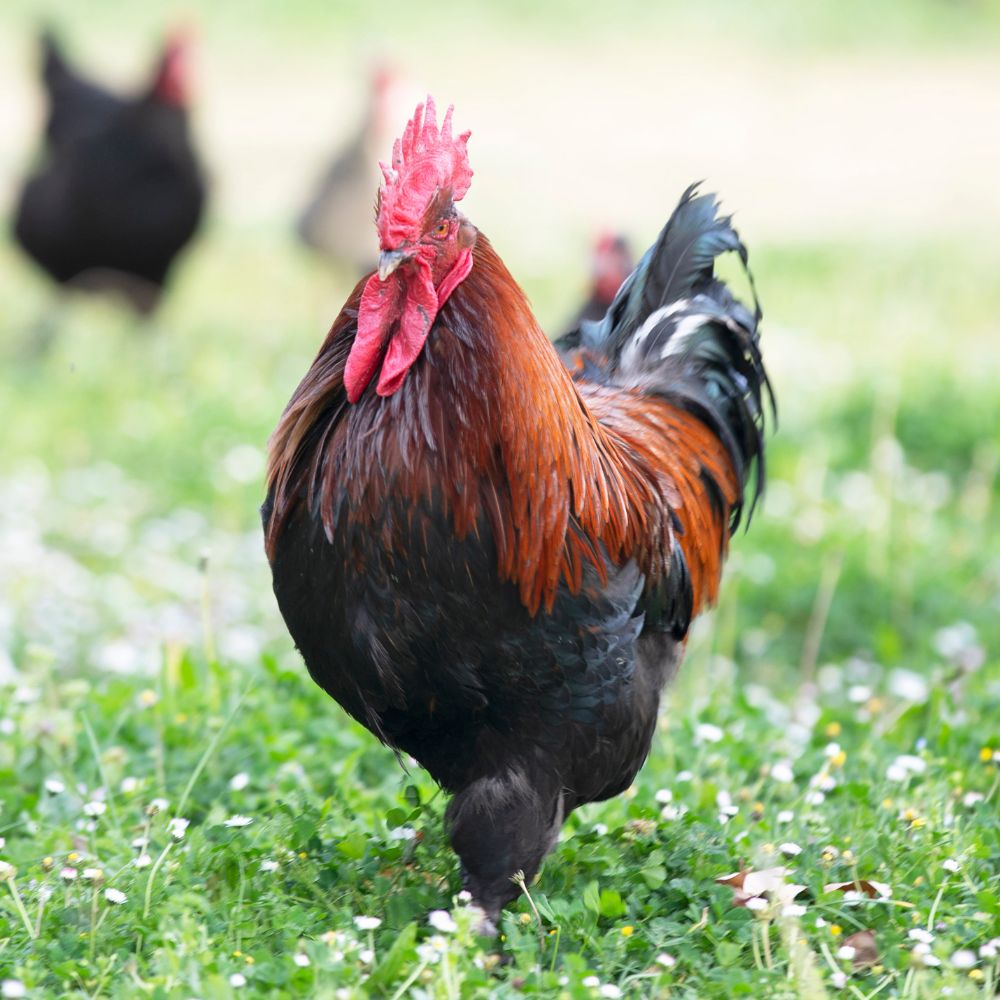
[268,235,672,613]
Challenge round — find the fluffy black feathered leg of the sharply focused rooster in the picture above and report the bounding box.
[446,768,563,935]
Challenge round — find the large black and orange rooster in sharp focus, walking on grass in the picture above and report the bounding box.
[262,98,770,931]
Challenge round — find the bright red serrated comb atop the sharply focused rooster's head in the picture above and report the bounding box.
[376,95,472,250]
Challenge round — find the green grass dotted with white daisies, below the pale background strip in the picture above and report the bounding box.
[0,217,1000,998]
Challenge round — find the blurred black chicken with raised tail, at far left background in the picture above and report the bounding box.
[14,31,206,314]
